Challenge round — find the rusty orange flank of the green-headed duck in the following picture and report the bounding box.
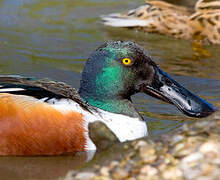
[0,94,86,155]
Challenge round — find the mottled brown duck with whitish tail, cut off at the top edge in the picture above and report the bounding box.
[101,0,220,44]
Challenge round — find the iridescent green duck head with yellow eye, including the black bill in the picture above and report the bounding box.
[79,41,215,117]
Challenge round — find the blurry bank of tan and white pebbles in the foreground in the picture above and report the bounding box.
[64,113,220,180]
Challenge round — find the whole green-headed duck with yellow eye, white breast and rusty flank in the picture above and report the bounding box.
[0,41,216,155]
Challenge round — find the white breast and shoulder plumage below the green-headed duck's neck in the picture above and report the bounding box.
[48,98,148,150]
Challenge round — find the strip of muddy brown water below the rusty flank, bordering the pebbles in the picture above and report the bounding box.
[0,143,128,180]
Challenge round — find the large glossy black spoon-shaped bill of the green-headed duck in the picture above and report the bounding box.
[142,67,216,117]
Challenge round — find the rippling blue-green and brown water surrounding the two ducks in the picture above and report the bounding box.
[0,0,220,179]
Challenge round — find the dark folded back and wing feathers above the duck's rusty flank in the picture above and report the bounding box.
[0,75,88,110]
